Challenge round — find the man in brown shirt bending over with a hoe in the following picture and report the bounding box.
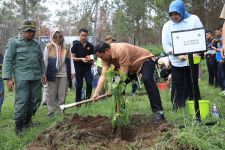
[93,42,164,123]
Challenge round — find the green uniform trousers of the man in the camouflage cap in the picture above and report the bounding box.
[14,80,42,120]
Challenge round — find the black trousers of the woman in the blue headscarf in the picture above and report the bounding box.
[171,65,201,110]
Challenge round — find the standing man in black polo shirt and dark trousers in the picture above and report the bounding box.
[71,28,94,102]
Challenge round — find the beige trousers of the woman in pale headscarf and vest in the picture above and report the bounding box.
[47,77,68,114]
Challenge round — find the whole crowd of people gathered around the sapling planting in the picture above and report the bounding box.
[0,0,225,137]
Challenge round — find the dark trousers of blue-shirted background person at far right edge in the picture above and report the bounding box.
[217,62,225,91]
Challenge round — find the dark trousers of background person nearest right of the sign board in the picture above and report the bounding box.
[206,55,218,86]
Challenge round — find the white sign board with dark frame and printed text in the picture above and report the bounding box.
[171,28,206,55]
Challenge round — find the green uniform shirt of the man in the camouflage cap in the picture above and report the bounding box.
[2,35,45,81]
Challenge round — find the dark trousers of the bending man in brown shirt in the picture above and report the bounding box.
[126,59,163,113]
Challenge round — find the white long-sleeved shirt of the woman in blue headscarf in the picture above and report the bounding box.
[162,15,203,67]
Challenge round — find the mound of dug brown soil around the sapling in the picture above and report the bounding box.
[28,114,172,150]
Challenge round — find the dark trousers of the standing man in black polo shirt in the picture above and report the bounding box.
[75,67,93,102]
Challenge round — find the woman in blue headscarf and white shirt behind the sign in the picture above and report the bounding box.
[162,0,203,110]
